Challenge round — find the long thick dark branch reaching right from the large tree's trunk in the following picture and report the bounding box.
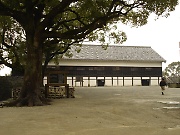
[41,0,144,39]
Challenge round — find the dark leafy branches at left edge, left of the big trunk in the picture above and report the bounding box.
[0,16,27,75]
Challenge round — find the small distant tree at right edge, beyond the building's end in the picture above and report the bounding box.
[163,61,180,77]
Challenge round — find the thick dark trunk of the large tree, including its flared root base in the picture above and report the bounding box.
[8,31,48,106]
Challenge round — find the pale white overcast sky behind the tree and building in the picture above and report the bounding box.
[0,0,180,76]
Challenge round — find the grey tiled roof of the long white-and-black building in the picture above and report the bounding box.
[63,45,165,62]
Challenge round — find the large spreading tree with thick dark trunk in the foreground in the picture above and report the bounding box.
[0,0,178,106]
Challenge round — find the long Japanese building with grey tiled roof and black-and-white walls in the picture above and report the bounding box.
[48,45,165,87]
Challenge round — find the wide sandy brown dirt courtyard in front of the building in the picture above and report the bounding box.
[0,86,180,135]
